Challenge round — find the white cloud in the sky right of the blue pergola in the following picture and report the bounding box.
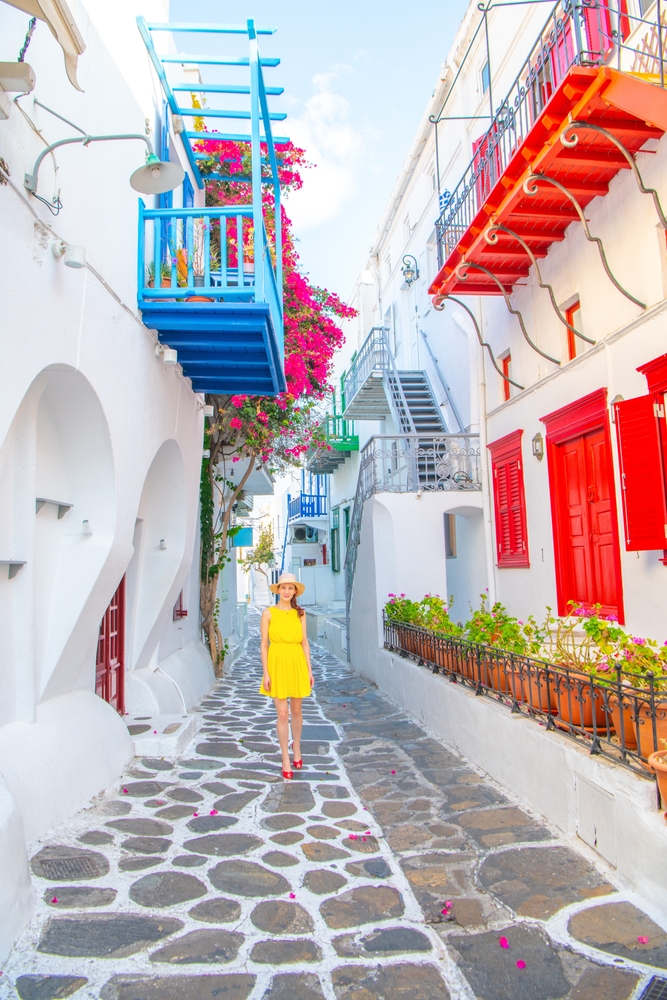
[287,65,364,231]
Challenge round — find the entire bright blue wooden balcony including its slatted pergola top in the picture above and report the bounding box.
[137,17,288,396]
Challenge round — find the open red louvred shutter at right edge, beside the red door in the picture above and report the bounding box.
[614,396,667,552]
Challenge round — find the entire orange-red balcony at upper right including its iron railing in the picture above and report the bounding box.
[429,0,667,296]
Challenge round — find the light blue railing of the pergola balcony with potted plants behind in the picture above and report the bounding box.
[137,200,283,351]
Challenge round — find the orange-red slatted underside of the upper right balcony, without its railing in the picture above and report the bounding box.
[429,67,667,295]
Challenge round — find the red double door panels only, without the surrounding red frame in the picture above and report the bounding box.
[554,427,619,615]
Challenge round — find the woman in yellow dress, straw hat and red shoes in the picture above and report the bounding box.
[259,573,315,778]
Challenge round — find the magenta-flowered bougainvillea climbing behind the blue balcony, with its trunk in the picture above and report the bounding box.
[195,127,355,663]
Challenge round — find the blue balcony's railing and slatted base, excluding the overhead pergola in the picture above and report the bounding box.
[138,201,285,396]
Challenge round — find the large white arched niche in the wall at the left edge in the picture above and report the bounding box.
[0,366,115,724]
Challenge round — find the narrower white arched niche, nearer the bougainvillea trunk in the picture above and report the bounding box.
[126,441,186,670]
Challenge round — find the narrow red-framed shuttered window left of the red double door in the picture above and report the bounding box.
[488,430,530,567]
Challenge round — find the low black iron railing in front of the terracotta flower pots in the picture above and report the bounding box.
[384,616,667,778]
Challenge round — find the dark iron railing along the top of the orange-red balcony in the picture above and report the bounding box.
[436,0,664,267]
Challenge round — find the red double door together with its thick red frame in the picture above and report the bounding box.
[543,390,623,621]
